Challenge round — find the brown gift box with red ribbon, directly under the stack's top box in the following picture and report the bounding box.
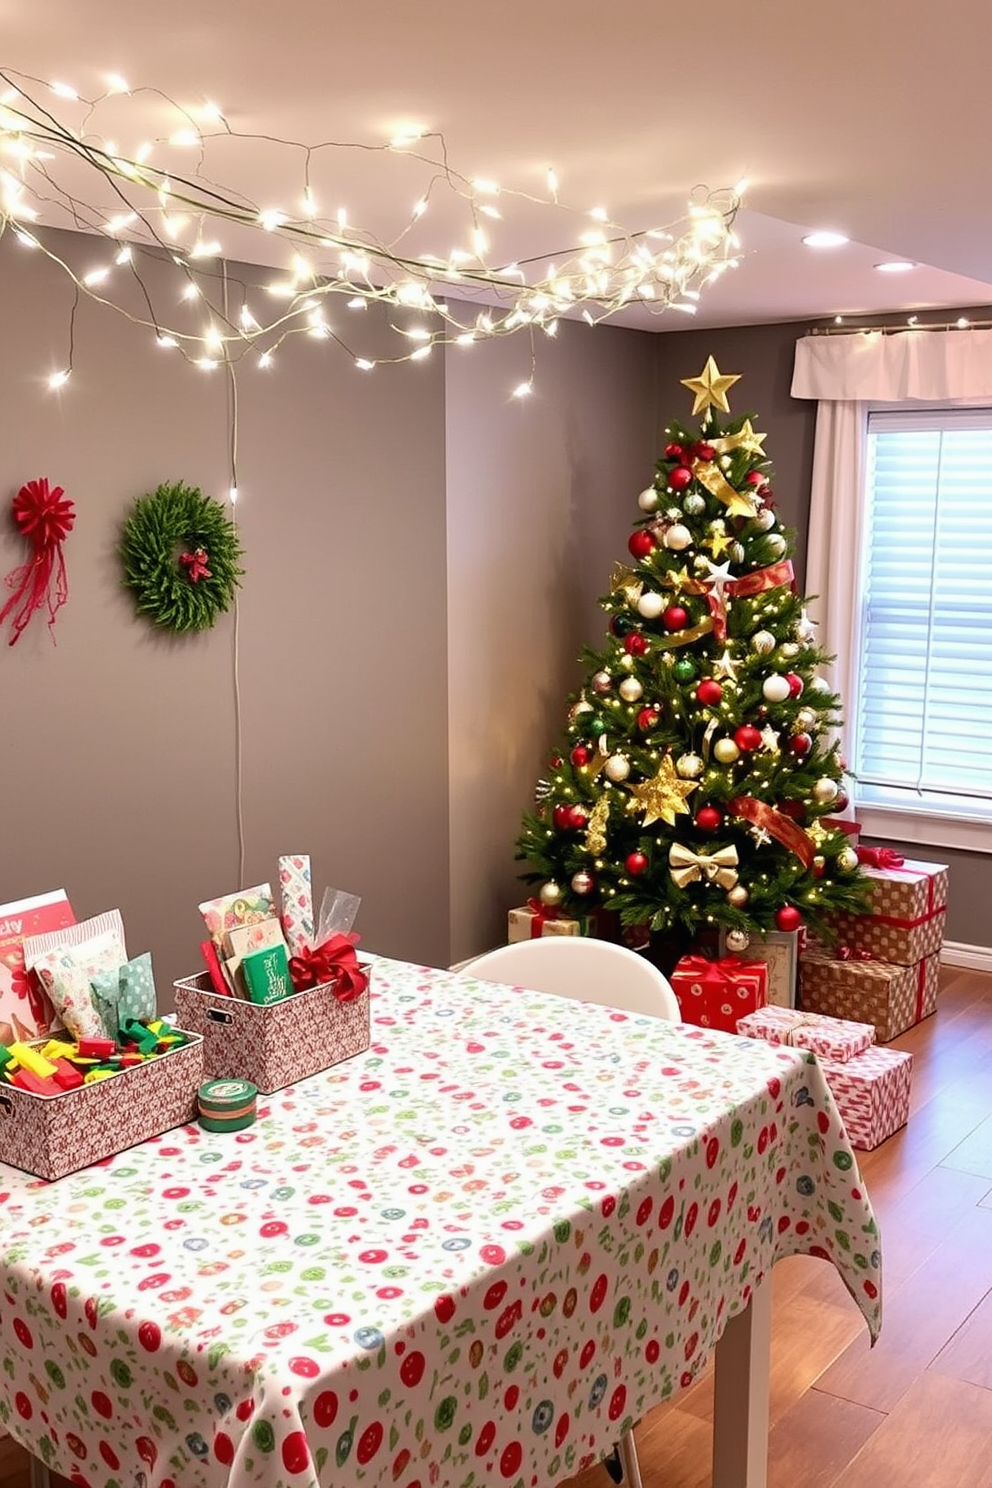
[799,949,940,1043]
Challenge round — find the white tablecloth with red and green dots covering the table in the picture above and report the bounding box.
[0,961,880,1488]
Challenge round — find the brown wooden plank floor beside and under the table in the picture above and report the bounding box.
[0,967,992,1488]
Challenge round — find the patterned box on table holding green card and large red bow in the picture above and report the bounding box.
[175,961,372,1095]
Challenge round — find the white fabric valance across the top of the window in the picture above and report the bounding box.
[793,330,992,403]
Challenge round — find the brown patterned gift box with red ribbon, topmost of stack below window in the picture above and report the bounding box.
[830,859,947,966]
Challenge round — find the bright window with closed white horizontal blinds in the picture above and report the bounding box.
[846,409,992,845]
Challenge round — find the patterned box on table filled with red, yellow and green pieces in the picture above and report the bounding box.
[0,1033,204,1178]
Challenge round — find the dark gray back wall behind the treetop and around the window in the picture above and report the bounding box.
[657,307,992,946]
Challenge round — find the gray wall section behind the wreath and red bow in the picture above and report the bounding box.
[0,234,449,988]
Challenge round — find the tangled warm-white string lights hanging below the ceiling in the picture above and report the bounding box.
[0,68,744,386]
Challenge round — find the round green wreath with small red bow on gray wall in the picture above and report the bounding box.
[120,482,244,634]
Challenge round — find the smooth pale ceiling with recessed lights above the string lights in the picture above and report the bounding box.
[0,0,992,330]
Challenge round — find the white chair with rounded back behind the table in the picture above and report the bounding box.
[458,936,681,1488]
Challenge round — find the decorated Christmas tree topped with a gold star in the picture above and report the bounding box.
[518,366,864,946]
